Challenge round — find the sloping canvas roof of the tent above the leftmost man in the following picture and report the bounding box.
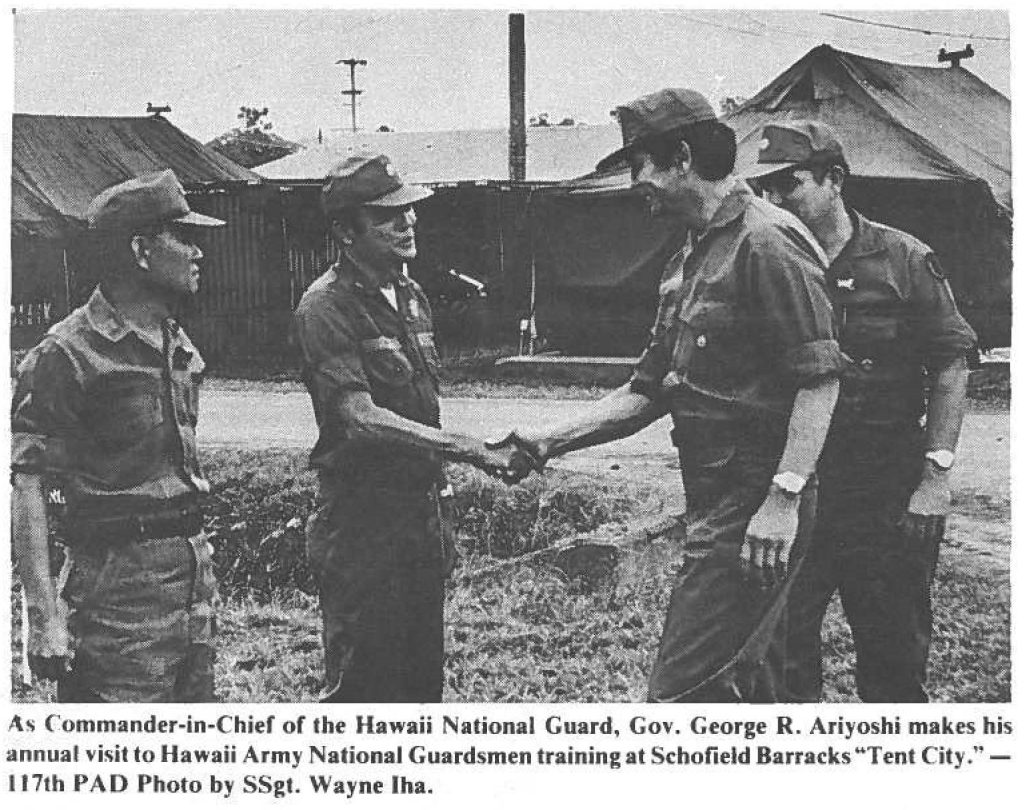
[11,114,260,236]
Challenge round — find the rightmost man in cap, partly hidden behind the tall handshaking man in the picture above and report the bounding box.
[750,121,976,702]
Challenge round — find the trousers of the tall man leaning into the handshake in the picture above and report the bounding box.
[648,420,815,702]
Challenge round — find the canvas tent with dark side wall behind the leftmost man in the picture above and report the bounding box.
[11,114,261,349]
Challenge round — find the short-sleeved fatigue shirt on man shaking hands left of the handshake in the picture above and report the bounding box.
[295,257,441,491]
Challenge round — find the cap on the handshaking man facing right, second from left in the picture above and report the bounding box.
[321,155,433,214]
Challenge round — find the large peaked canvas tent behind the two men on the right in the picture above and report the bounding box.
[531,45,1012,354]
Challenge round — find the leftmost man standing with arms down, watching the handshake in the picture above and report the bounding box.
[11,170,224,702]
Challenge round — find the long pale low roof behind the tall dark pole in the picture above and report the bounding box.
[258,125,622,183]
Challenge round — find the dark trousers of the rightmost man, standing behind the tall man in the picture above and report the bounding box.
[786,425,942,702]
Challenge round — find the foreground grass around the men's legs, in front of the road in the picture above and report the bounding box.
[13,451,1010,702]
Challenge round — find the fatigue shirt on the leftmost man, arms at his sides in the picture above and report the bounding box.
[11,287,210,518]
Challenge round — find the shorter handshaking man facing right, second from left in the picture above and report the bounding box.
[295,155,520,702]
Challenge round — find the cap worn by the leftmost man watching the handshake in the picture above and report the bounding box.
[85,169,224,231]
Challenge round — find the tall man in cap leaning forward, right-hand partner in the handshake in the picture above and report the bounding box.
[491,89,841,701]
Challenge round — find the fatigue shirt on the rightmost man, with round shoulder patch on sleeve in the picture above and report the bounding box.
[826,211,977,426]
